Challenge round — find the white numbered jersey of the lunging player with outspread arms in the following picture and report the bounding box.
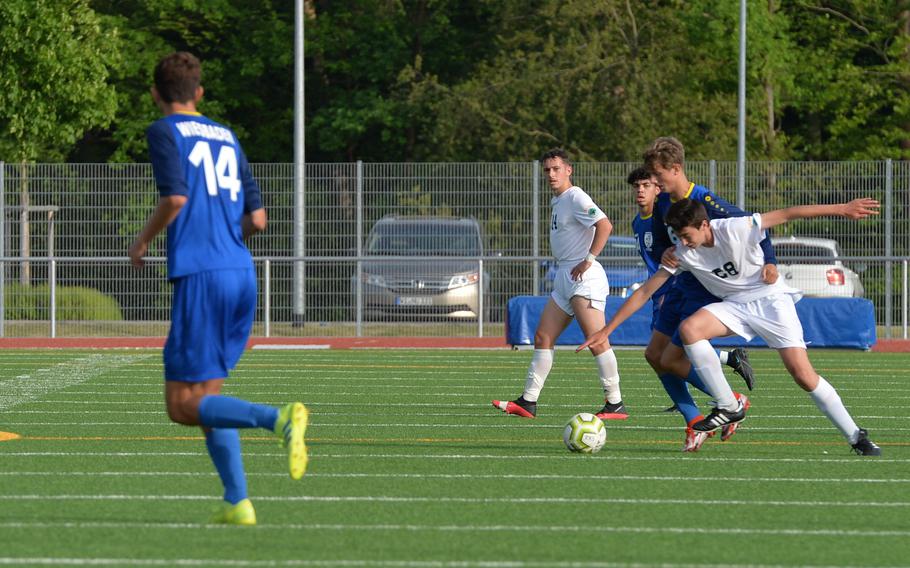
[671,213,801,302]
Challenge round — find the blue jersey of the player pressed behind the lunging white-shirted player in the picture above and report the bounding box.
[652,183,777,301]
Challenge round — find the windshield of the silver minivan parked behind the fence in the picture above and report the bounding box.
[367,223,481,256]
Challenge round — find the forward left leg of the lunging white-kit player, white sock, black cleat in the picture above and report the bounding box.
[679,309,746,432]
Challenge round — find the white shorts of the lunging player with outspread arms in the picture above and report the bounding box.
[704,294,806,349]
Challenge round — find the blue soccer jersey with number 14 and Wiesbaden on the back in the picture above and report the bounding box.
[147,113,262,280]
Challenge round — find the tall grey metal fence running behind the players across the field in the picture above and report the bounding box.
[0,161,910,337]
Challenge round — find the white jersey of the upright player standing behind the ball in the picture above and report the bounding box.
[550,189,607,264]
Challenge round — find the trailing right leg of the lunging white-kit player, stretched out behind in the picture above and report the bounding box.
[777,347,882,456]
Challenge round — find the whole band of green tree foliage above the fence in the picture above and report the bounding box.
[0,0,910,162]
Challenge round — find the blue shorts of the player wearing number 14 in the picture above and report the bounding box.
[164,268,256,382]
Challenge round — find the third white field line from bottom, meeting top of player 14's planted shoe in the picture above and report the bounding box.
[0,494,910,508]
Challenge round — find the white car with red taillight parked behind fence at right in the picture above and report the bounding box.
[771,236,865,298]
